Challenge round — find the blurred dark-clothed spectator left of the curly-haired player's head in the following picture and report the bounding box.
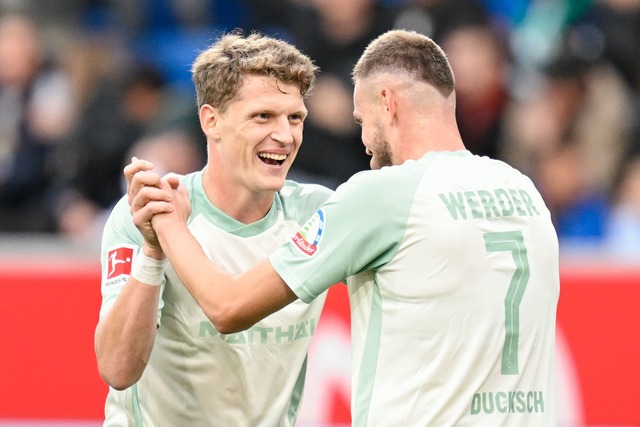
[52,64,204,241]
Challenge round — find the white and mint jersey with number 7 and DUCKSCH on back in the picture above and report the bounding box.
[270,151,559,427]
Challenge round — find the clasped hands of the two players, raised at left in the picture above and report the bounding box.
[124,157,191,258]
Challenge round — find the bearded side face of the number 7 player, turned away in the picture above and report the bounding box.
[353,80,393,169]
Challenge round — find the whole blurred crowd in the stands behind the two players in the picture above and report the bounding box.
[0,0,640,262]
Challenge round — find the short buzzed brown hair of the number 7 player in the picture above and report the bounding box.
[352,30,455,97]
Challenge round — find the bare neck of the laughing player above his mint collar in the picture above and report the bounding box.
[202,166,275,224]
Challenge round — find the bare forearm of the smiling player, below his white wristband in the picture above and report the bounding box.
[95,276,160,390]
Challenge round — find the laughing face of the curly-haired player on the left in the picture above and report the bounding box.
[208,74,307,193]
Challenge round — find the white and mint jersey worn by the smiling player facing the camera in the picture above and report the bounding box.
[101,172,331,427]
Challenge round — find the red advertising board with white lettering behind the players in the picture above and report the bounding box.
[0,260,640,426]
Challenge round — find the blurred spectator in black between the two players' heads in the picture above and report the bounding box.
[262,0,393,188]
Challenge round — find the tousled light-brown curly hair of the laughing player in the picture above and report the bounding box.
[191,32,318,112]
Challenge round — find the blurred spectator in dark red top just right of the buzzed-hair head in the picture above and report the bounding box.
[394,0,511,163]
